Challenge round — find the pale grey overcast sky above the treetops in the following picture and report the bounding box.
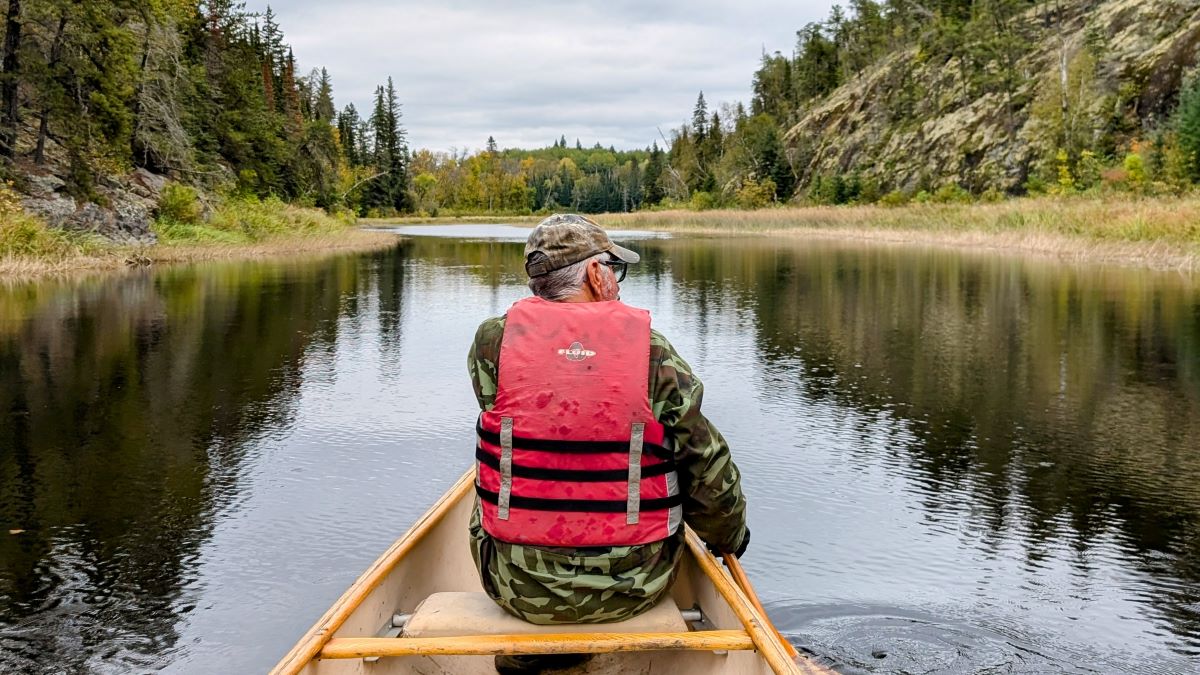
[248,0,834,150]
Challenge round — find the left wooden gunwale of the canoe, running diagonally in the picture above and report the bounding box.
[271,468,475,675]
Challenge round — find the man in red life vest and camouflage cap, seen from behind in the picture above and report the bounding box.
[468,215,750,673]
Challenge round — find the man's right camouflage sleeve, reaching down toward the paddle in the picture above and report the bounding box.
[650,330,749,551]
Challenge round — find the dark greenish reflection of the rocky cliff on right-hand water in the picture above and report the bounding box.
[666,241,1200,635]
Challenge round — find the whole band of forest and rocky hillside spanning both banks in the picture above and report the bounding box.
[0,0,1200,215]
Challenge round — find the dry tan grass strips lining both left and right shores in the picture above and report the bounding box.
[9,197,1200,280]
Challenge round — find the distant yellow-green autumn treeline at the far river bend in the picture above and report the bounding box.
[412,100,794,214]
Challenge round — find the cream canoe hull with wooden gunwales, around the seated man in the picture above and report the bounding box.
[272,472,824,675]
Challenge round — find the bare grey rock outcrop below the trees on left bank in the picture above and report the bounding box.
[23,169,167,244]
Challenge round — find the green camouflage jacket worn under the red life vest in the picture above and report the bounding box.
[467,317,748,623]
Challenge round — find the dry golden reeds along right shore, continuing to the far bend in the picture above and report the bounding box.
[364,197,1200,271]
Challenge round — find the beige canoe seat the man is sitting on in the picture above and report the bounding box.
[403,592,688,638]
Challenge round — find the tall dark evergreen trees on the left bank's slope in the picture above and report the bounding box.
[0,0,410,210]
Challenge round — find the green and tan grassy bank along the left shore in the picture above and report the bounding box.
[0,199,396,280]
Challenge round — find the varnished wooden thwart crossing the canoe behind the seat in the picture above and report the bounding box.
[319,631,755,658]
